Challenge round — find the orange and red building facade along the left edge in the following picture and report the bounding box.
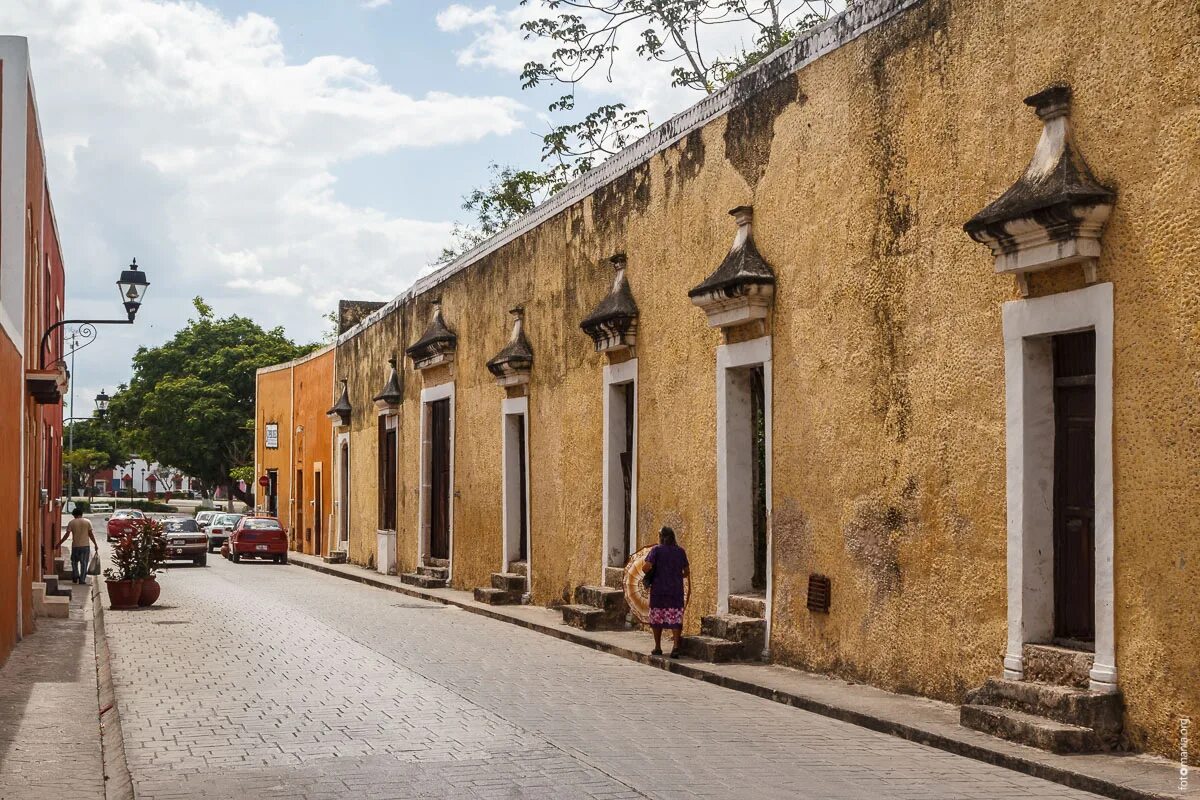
[0,36,67,663]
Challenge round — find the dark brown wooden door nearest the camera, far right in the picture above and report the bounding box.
[1054,331,1096,642]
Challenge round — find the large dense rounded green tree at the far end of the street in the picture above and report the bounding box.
[108,297,316,499]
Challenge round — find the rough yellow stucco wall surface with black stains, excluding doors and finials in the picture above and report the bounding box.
[307,0,1200,753]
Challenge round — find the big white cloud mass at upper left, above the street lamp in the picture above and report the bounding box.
[0,0,526,407]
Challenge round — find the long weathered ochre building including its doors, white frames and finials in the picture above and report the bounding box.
[259,0,1200,756]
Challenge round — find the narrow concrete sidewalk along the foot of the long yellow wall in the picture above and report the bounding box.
[288,553,1180,800]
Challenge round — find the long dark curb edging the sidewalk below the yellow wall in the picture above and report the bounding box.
[288,558,1180,800]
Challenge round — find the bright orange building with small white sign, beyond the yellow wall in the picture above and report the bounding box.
[254,345,334,555]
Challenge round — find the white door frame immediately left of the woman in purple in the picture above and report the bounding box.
[600,359,637,578]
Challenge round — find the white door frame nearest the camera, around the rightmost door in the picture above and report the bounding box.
[1003,283,1117,692]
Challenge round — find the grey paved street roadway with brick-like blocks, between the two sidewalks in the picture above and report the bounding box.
[96,551,1094,800]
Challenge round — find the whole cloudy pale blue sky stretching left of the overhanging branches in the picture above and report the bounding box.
[0,0,825,416]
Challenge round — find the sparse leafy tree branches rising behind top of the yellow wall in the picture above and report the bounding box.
[436,0,840,264]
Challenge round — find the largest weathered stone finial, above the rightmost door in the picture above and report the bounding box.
[964,85,1116,296]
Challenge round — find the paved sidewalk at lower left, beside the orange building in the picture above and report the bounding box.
[0,583,104,800]
